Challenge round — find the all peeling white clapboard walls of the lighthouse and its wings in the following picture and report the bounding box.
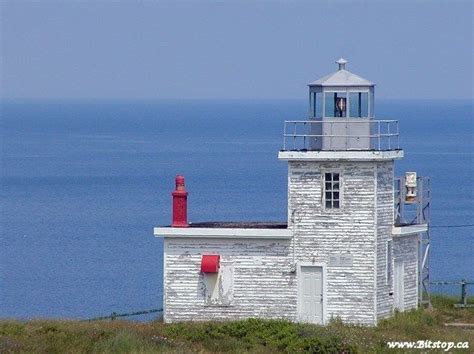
[164,160,418,325]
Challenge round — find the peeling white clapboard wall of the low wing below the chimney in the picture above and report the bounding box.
[163,238,296,322]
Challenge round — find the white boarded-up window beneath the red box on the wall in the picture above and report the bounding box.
[203,262,234,306]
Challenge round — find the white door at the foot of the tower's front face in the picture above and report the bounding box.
[299,266,323,324]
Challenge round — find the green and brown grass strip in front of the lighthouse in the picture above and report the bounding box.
[0,296,474,353]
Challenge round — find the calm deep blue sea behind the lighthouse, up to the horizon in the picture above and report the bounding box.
[0,100,474,319]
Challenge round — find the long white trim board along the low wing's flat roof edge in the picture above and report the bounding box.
[153,227,293,240]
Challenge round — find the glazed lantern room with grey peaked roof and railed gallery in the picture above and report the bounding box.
[294,58,398,151]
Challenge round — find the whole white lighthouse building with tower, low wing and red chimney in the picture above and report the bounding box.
[154,59,428,325]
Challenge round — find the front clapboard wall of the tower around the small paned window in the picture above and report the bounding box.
[288,161,377,324]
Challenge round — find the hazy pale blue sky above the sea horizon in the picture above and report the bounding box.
[0,0,474,98]
